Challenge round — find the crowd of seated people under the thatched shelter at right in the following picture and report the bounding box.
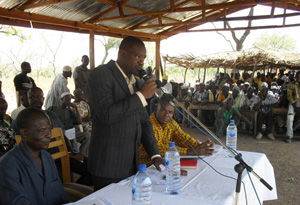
[149,67,300,143]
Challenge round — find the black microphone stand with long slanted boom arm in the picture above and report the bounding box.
[168,96,273,204]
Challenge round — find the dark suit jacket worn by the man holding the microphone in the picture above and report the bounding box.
[87,60,159,178]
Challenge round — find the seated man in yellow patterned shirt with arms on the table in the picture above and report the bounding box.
[139,95,214,166]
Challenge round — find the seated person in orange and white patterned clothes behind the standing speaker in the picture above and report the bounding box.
[73,88,92,132]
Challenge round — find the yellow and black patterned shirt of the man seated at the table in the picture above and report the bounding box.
[139,113,198,166]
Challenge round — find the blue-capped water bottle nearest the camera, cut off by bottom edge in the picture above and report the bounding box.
[131,164,152,205]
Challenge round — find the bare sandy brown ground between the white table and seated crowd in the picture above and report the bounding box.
[183,128,300,205]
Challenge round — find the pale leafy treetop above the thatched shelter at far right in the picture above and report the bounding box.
[253,32,296,51]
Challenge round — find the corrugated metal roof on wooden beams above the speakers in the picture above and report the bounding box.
[0,0,300,39]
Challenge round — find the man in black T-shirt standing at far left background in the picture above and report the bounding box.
[14,62,36,107]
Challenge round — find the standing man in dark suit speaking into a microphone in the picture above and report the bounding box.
[87,36,164,190]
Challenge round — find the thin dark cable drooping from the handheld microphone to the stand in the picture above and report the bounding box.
[158,99,248,205]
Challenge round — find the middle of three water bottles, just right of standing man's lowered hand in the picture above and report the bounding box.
[165,142,181,195]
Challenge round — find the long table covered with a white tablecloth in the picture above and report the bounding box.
[67,150,277,205]
